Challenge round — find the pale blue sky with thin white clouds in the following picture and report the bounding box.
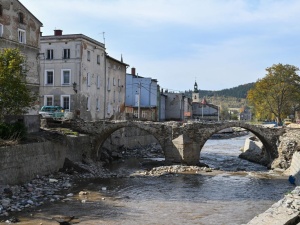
[20,0,300,91]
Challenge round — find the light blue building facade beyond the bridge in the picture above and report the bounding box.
[125,68,159,121]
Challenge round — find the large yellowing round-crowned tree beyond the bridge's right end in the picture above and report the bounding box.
[247,63,300,123]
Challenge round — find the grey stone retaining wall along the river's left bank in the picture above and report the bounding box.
[0,135,91,185]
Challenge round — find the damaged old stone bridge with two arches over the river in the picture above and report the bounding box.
[71,120,285,165]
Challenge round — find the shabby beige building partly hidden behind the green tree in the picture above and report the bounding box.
[0,0,42,114]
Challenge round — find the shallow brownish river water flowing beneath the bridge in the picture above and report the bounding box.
[4,134,294,225]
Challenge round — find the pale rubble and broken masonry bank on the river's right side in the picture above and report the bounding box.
[240,129,300,225]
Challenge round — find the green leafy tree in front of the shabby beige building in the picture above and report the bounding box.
[0,48,36,120]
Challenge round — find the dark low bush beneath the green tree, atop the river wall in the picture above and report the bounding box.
[0,122,27,140]
